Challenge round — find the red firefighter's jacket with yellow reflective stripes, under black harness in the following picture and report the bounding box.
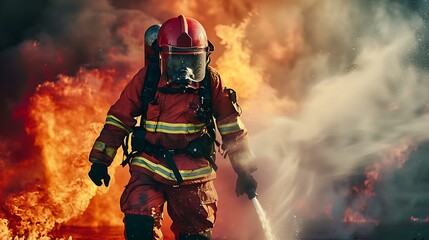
[90,67,255,184]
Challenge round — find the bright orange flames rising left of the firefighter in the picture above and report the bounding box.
[1,69,129,239]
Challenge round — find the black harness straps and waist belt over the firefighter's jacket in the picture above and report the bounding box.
[121,51,219,185]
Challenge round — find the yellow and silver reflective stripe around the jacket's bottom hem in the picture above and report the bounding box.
[131,156,213,181]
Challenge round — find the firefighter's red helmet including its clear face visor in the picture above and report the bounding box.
[157,15,214,84]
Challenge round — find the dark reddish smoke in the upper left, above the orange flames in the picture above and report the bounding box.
[0,0,153,136]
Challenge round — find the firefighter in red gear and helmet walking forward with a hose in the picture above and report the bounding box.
[85,15,257,240]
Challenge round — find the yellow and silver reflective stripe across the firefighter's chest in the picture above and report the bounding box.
[144,121,205,134]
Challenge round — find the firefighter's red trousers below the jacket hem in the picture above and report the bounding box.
[121,172,218,239]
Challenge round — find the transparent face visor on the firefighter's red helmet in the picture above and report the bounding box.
[165,52,207,82]
